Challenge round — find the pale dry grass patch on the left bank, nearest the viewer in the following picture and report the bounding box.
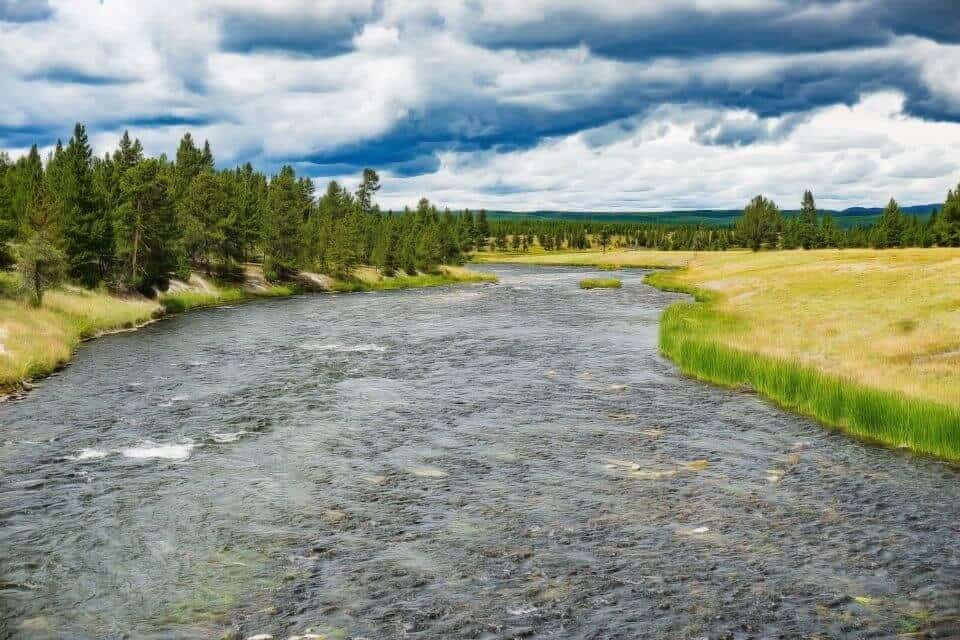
[0,288,159,390]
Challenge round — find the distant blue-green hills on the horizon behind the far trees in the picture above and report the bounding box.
[487,204,942,228]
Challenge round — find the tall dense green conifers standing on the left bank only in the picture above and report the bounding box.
[0,124,474,303]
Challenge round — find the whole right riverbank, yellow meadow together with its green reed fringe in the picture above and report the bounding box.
[472,249,960,460]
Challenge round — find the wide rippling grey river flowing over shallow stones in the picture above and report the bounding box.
[0,267,960,640]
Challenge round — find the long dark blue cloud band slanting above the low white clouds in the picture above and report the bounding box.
[296,50,948,175]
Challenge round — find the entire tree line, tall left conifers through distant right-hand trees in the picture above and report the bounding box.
[0,123,960,303]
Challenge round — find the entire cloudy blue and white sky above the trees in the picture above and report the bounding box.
[0,0,960,211]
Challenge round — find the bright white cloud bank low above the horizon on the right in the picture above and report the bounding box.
[382,93,960,211]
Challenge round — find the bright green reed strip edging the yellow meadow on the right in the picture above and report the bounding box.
[647,272,960,460]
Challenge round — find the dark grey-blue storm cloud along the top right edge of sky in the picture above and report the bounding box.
[469,0,960,60]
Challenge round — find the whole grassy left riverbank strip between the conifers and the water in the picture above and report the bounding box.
[0,265,496,396]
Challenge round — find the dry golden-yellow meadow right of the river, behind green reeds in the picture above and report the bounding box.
[672,249,960,406]
